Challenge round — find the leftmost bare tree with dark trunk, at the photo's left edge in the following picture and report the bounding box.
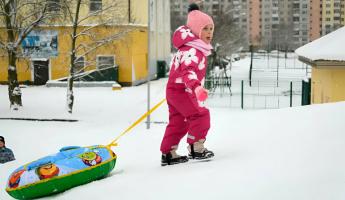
[0,0,52,110]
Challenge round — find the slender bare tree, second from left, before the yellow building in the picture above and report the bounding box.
[62,0,135,113]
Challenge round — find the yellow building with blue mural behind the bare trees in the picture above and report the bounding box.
[0,0,170,85]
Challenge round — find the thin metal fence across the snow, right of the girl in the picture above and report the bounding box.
[206,77,302,109]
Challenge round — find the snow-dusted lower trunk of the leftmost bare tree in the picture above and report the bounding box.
[8,51,22,110]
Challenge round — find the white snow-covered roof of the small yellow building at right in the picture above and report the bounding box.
[295,27,345,62]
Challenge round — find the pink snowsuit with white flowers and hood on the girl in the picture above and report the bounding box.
[161,26,210,154]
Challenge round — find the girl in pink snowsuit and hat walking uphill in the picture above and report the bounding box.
[161,4,214,166]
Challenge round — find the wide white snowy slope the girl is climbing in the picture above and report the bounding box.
[0,79,345,200]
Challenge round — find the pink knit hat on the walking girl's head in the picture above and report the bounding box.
[187,10,214,38]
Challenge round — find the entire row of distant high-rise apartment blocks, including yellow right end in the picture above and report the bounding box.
[171,0,345,50]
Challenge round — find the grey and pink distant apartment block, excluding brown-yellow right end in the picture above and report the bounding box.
[171,0,310,50]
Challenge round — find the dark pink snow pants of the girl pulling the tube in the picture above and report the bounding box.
[161,88,210,154]
